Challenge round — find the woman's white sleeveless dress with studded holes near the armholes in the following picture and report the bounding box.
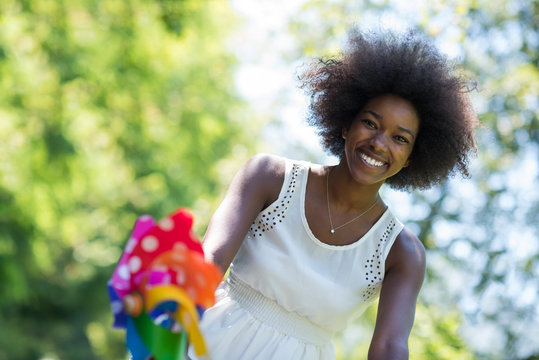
[188,160,403,360]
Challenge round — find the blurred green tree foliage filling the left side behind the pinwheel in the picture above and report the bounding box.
[0,0,256,360]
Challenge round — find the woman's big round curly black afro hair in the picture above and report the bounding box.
[299,29,478,190]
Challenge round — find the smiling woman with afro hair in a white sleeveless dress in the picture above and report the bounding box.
[190,32,476,360]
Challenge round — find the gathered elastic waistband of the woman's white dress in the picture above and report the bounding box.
[224,272,333,345]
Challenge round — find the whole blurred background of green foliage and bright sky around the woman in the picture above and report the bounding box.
[0,0,539,360]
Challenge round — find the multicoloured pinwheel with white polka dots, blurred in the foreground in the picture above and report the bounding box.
[108,209,222,360]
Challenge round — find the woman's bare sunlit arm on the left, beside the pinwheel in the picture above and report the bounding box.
[202,154,285,273]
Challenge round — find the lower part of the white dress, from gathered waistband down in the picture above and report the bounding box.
[189,275,336,360]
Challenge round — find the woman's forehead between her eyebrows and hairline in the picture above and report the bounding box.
[360,94,419,132]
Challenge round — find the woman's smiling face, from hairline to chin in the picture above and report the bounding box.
[342,94,419,185]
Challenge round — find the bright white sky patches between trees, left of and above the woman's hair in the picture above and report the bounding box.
[231,0,468,161]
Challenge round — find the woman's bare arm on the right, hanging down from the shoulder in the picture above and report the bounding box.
[368,228,425,360]
